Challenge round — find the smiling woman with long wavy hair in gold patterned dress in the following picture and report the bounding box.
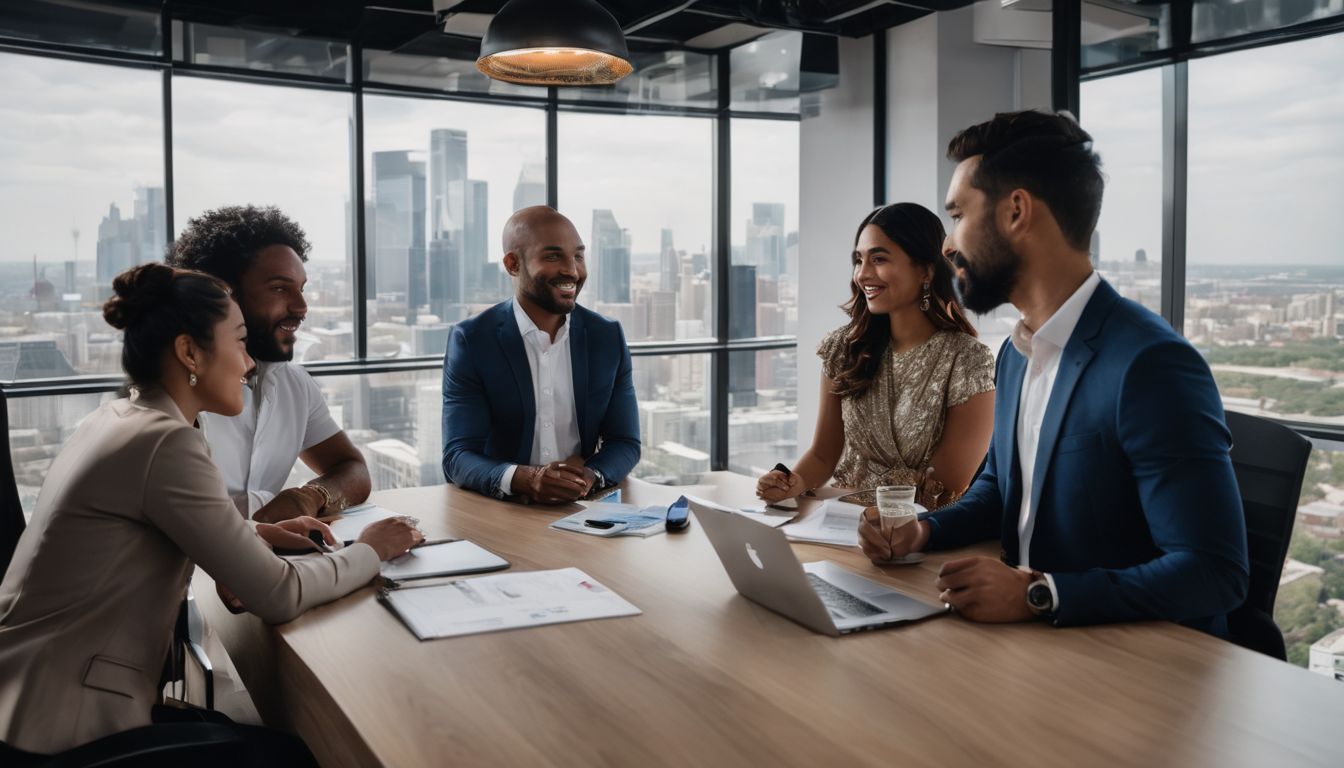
[757,203,995,510]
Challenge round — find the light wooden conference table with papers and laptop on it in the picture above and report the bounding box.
[196,472,1344,767]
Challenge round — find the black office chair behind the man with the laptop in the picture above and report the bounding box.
[1227,412,1312,660]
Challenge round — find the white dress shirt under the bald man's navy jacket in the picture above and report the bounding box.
[500,299,583,496]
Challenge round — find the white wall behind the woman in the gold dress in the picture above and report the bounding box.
[795,38,874,443]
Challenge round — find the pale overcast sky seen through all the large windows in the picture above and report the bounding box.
[0,35,1344,277]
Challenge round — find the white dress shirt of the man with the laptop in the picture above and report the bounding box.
[1012,272,1101,609]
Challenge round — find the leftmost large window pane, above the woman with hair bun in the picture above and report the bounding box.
[0,54,168,379]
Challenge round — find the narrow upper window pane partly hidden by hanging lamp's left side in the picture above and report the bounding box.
[363,43,546,98]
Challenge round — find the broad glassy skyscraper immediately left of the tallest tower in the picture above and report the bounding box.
[374,149,426,321]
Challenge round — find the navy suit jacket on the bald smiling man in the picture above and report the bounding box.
[444,299,640,496]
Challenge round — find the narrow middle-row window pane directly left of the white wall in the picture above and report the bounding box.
[728,120,800,339]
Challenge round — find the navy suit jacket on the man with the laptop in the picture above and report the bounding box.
[929,280,1249,636]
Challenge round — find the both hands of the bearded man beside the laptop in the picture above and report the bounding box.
[859,507,1034,623]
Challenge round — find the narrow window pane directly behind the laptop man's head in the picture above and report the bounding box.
[1079,69,1163,312]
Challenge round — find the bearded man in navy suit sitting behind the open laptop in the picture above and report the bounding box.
[860,112,1249,636]
